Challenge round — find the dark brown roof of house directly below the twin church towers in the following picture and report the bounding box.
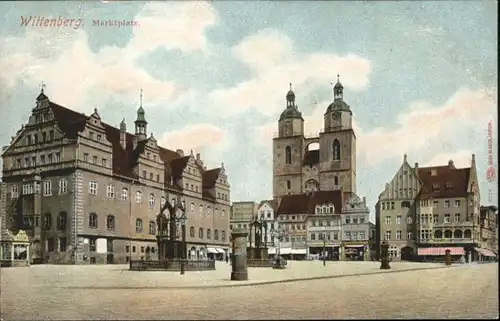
[277,190,343,215]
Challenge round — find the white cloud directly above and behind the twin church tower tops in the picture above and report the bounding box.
[209,30,371,115]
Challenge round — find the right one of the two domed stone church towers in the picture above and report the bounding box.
[319,75,356,193]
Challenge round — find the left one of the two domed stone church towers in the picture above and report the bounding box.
[273,84,304,198]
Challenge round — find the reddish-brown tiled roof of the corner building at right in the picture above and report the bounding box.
[417,165,470,199]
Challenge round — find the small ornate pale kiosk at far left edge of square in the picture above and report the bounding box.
[0,230,30,267]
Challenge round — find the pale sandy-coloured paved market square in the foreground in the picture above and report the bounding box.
[1,262,499,320]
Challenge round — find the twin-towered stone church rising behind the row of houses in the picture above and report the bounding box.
[273,77,356,199]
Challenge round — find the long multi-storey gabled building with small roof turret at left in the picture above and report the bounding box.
[2,90,230,264]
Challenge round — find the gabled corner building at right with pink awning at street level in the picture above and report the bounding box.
[376,155,480,260]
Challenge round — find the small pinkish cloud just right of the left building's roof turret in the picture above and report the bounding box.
[158,123,227,154]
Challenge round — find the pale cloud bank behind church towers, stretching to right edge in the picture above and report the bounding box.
[256,88,497,168]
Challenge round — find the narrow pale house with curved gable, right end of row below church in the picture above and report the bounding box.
[341,193,370,261]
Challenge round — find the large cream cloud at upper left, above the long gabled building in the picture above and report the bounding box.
[0,2,216,111]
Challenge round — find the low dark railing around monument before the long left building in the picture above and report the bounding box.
[130,259,215,271]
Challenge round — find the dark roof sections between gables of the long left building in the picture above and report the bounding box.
[30,93,225,195]
